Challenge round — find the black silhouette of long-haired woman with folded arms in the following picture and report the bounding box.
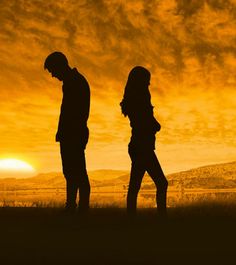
[120,66,168,213]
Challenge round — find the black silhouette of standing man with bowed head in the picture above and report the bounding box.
[44,52,90,212]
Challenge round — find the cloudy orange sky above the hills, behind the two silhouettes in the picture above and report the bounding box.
[0,0,236,173]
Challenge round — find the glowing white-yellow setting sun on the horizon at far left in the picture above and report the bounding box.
[0,158,35,173]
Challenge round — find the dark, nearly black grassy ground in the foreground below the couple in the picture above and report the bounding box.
[0,205,236,265]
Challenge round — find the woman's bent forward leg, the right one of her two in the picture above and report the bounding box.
[146,151,168,213]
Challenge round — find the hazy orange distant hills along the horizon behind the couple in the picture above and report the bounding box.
[0,162,236,190]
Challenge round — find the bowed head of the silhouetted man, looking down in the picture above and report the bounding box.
[44,52,70,81]
